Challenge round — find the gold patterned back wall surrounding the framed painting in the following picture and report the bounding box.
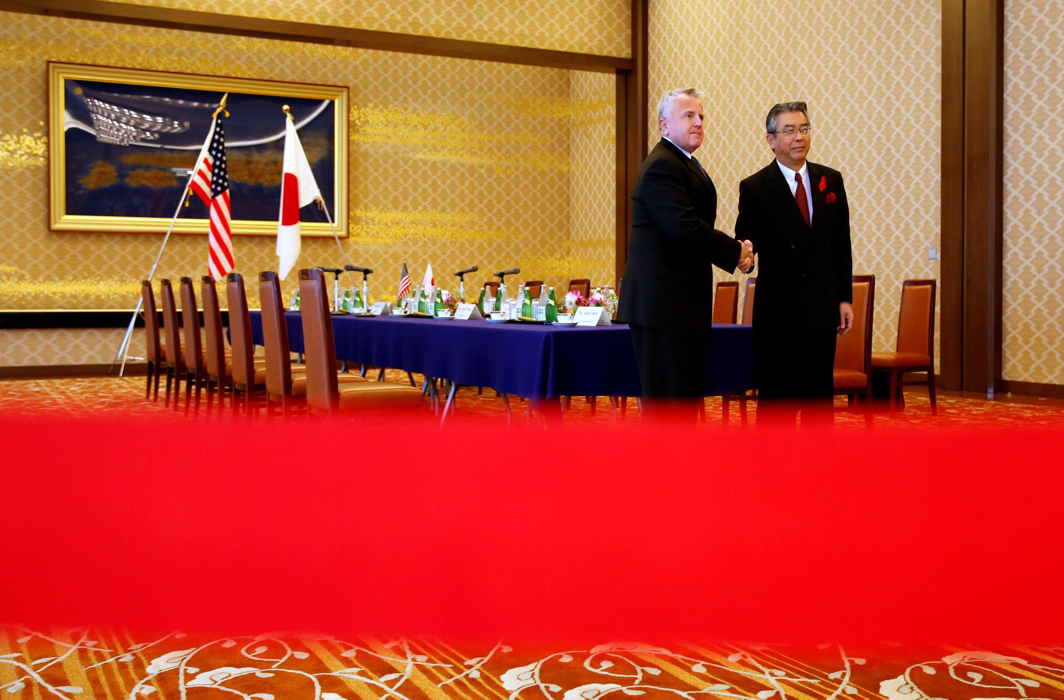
[0,13,614,364]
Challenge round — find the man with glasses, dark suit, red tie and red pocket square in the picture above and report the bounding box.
[735,102,853,424]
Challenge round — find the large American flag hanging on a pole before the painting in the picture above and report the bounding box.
[188,118,233,280]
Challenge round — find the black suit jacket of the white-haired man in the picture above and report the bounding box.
[619,138,741,328]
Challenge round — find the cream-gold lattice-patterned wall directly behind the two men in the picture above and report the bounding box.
[648,0,942,359]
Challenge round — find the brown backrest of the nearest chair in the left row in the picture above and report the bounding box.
[299,269,339,411]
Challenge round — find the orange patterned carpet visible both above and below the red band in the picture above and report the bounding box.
[0,372,1064,700]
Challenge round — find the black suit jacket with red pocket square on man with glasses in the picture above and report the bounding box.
[735,161,853,331]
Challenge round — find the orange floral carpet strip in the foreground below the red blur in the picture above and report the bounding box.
[0,627,1064,700]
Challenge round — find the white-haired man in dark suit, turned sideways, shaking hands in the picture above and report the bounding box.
[620,88,752,407]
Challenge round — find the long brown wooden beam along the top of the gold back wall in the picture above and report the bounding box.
[0,0,635,72]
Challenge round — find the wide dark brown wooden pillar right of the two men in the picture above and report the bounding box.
[940,0,1004,395]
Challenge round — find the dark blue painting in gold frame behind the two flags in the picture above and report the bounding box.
[48,62,348,236]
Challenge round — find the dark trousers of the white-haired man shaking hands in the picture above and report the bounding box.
[630,324,710,411]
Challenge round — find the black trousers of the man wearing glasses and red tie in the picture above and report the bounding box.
[753,326,838,427]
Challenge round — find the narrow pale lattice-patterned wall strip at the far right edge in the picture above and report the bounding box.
[1001,0,1064,384]
